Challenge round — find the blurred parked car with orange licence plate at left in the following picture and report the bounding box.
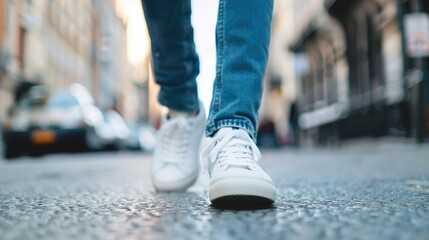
[2,84,103,158]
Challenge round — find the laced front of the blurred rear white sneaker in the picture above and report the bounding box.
[158,117,192,164]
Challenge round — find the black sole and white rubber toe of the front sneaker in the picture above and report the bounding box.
[209,179,276,209]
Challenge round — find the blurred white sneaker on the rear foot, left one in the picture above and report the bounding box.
[152,103,206,191]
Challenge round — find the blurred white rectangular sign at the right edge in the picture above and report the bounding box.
[404,13,429,58]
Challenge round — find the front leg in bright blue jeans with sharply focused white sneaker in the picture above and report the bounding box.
[203,0,276,208]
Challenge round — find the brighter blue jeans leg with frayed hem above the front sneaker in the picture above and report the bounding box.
[206,0,273,140]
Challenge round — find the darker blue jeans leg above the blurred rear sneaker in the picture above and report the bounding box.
[142,0,199,112]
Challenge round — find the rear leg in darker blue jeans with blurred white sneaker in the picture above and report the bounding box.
[142,0,205,191]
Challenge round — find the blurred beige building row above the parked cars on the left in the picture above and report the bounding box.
[0,0,133,124]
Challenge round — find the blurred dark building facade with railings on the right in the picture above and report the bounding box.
[280,0,429,144]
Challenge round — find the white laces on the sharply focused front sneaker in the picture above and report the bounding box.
[201,133,261,174]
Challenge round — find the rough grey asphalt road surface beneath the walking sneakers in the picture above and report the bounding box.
[0,141,429,240]
